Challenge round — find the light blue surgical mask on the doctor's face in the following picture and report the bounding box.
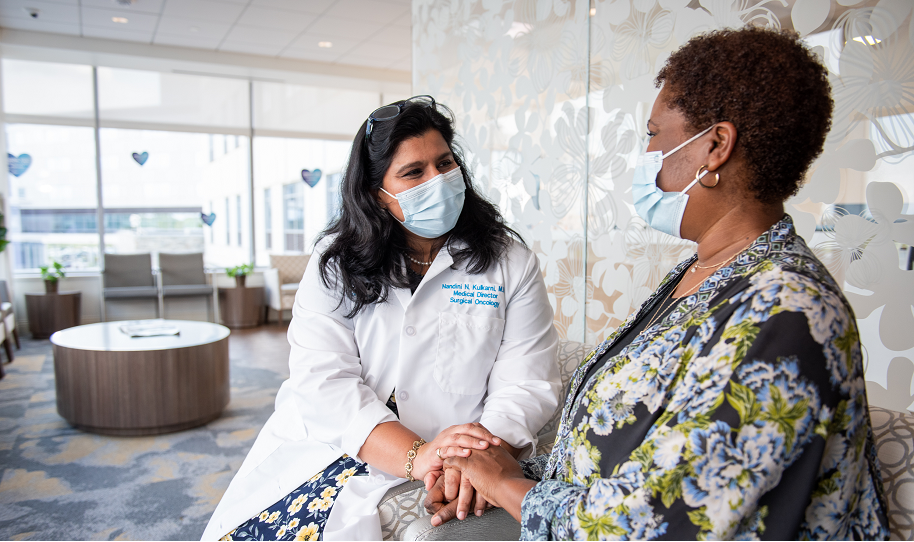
[381,167,466,239]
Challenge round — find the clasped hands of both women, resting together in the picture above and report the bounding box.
[417,424,533,526]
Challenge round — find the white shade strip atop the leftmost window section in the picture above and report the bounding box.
[3,58,93,119]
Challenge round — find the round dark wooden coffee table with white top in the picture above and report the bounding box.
[51,320,229,436]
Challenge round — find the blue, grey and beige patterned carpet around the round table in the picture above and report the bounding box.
[0,325,288,540]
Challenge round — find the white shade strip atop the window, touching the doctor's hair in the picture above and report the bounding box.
[254,82,381,140]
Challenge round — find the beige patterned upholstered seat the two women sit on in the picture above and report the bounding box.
[378,341,914,540]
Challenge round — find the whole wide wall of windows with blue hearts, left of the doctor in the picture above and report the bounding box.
[2,59,381,271]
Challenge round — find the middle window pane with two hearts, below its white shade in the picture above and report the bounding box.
[100,128,250,267]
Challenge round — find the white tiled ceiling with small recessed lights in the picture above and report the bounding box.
[0,0,412,71]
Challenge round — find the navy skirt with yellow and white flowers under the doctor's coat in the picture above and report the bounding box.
[221,454,368,540]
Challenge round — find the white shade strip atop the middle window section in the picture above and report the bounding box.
[98,68,250,129]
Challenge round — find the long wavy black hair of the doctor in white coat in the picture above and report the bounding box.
[318,102,523,318]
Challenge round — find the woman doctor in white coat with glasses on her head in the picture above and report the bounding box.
[203,96,561,540]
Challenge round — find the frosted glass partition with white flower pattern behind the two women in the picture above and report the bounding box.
[413,0,914,409]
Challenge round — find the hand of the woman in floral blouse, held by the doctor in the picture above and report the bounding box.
[444,446,536,520]
